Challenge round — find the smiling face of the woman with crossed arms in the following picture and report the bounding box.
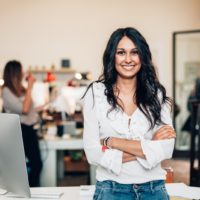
[115,36,141,79]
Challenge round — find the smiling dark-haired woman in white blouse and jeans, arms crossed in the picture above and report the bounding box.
[83,28,176,200]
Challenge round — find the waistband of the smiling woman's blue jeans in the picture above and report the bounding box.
[96,180,165,191]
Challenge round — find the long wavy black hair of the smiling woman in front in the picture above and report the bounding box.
[83,27,172,129]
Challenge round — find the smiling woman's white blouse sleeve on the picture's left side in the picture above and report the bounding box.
[83,88,123,175]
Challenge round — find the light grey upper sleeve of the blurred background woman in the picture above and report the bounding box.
[2,88,23,114]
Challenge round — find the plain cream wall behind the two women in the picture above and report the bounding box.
[0,0,200,95]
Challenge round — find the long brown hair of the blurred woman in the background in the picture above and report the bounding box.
[3,60,25,97]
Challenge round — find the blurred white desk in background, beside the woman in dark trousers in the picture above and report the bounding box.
[40,136,83,187]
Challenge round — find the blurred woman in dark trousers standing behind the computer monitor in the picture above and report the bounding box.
[2,60,42,187]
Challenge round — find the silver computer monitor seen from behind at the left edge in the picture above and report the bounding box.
[0,113,30,197]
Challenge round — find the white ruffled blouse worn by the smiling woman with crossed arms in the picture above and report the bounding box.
[83,83,174,184]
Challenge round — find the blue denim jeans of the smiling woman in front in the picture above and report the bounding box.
[93,180,169,200]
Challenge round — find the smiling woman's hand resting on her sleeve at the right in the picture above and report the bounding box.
[152,125,176,140]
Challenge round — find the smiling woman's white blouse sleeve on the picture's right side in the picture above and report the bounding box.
[137,103,175,169]
